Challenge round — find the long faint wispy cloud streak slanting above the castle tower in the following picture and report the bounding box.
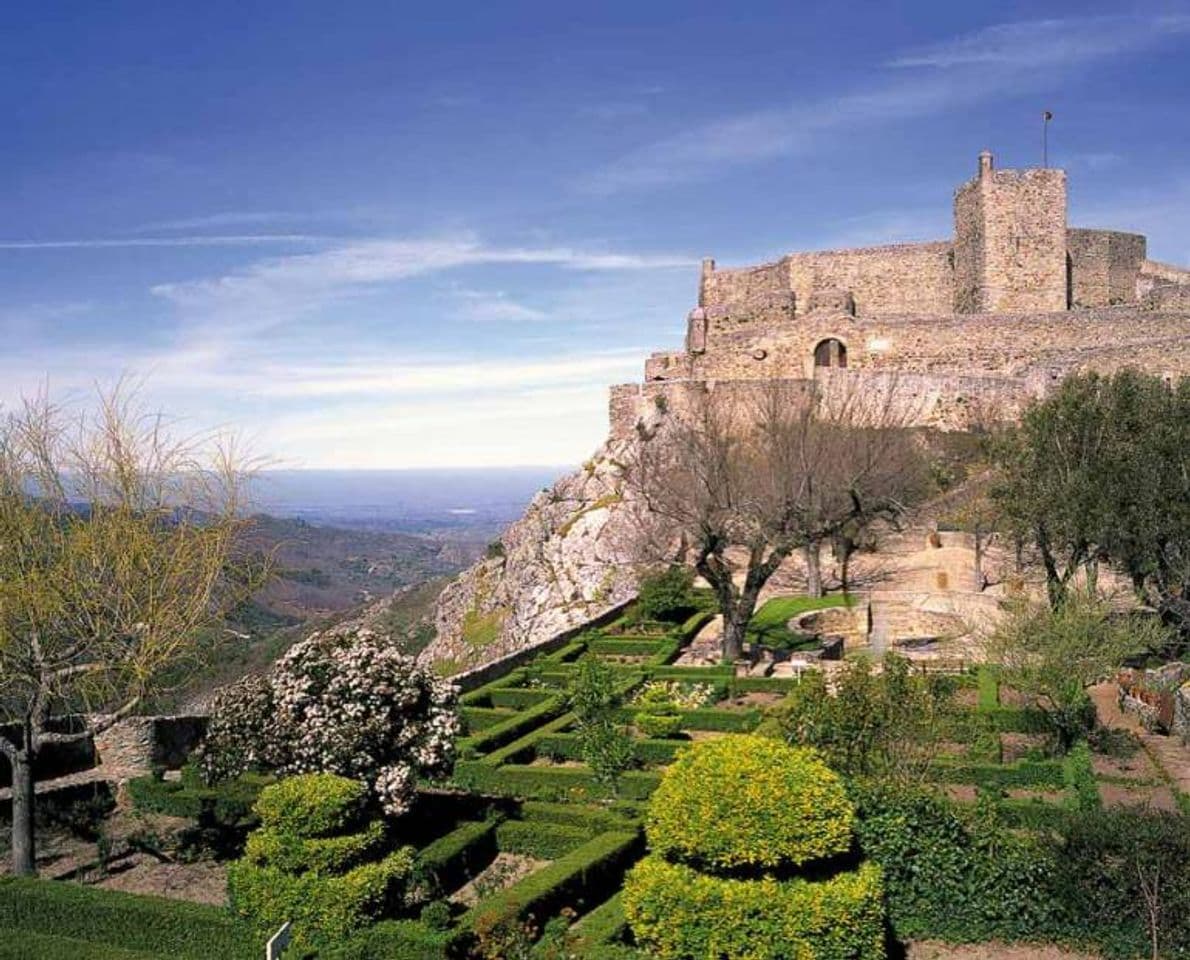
[578,14,1190,194]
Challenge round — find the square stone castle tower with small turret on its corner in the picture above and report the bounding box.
[954,150,1070,313]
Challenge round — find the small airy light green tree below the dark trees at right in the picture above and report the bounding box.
[987,590,1166,749]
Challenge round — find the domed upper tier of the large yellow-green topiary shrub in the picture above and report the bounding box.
[645,736,854,868]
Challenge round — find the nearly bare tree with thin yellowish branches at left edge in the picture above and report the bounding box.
[0,388,267,874]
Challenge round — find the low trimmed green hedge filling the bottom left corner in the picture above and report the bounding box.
[0,878,256,960]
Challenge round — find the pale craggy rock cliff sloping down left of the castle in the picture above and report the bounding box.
[420,440,640,673]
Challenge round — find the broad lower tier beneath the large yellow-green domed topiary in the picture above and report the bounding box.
[624,855,884,960]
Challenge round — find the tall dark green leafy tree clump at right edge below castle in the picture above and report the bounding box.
[992,370,1190,641]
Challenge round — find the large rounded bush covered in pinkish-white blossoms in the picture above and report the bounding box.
[201,629,459,816]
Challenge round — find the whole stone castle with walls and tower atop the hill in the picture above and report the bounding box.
[610,151,1190,439]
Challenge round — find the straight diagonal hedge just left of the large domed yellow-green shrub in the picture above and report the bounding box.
[459,830,640,929]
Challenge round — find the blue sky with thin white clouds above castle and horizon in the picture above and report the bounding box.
[0,0,1190,468]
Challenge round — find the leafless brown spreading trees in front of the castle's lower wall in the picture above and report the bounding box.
[625,381,925,659]
